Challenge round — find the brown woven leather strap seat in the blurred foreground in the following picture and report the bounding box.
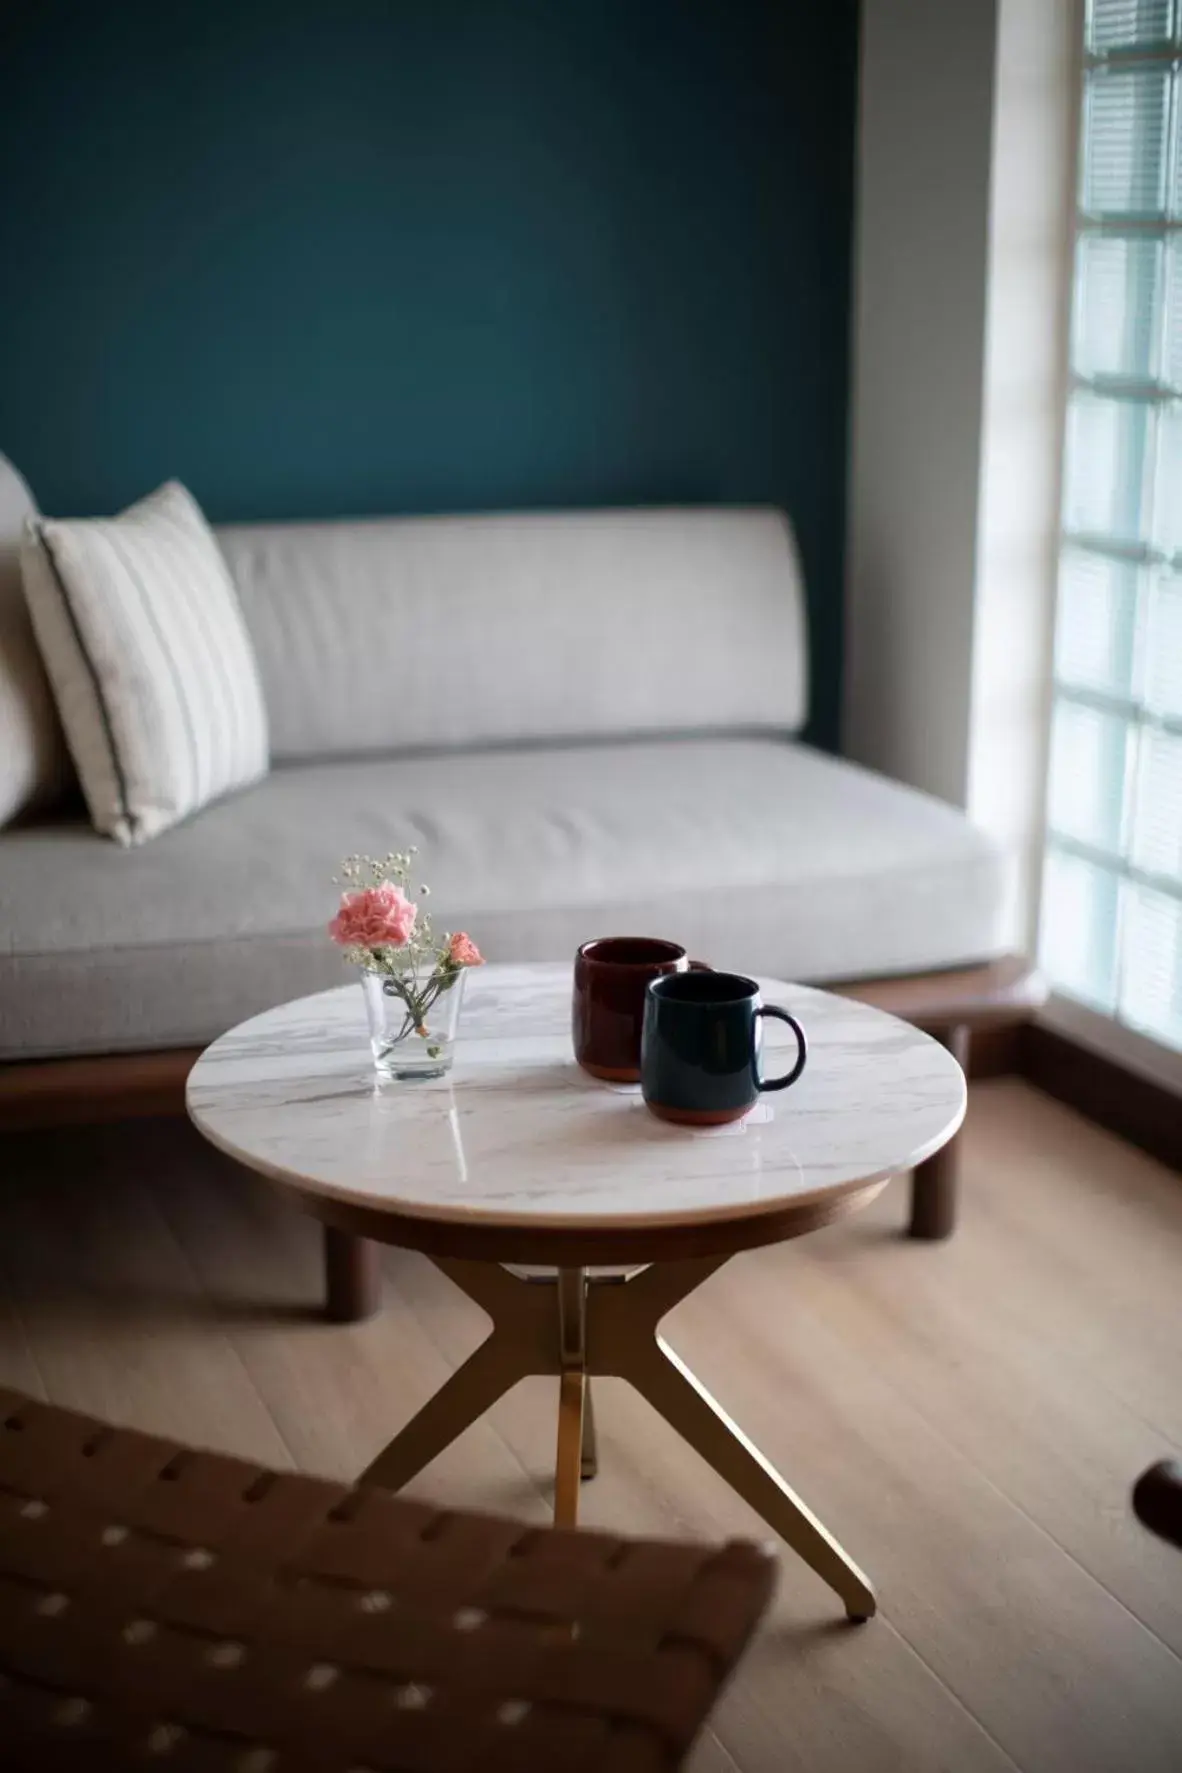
[0,1388,774,1773]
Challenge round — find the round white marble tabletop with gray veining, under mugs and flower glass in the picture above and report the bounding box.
[188,965,966,1230]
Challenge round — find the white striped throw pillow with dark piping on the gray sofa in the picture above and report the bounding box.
[21,480,268,844]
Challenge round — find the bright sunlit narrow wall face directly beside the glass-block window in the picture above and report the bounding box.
[966,0,1081,945]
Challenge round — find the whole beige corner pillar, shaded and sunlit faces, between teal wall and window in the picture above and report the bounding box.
[844,0,1077,943]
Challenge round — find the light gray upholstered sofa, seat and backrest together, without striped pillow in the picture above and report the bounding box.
[0,464,1026,1283]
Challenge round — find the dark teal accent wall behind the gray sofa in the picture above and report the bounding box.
[0,0,858,745]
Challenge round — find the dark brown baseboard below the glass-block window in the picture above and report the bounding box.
[1015,1021,1182,1170]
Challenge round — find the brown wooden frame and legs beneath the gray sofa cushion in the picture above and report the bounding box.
[0,954,1046,1323]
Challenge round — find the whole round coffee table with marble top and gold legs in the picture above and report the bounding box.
[188,966,966,1619]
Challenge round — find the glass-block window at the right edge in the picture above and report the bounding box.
[1040,0,1182,1050]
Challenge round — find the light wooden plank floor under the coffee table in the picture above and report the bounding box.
[0,1080,1182,1773]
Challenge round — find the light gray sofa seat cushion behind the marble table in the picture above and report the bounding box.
[0,738,1005,1058]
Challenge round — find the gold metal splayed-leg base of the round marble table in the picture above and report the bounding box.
[360,1255,877,1621]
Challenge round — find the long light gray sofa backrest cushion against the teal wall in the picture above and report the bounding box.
[218,509,806,761]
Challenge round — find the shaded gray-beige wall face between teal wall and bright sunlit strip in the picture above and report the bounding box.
[845,0,998,805]
